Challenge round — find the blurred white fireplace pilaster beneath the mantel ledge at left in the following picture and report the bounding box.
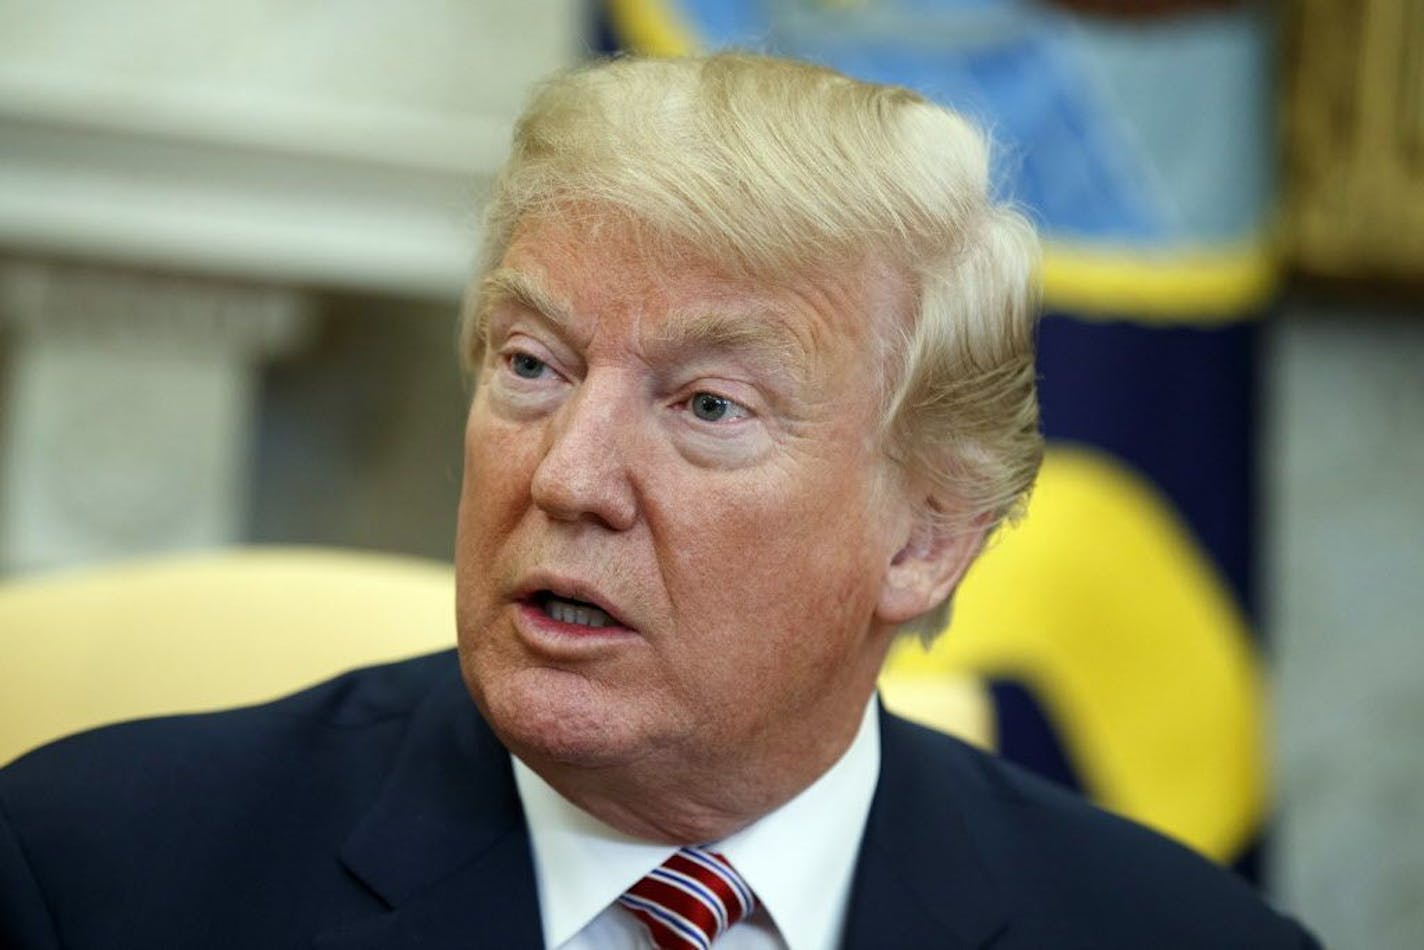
[0,262,308,573]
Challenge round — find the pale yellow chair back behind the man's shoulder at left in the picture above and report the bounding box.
[0,548,454,763]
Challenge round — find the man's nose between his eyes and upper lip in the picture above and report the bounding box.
[530,379,638,531]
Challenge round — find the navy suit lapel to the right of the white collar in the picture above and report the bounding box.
[844,711,1008,950]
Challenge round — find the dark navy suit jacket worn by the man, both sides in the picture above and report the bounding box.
[0,652,1314,950]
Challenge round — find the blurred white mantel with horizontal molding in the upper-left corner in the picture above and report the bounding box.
[0,0,580,299]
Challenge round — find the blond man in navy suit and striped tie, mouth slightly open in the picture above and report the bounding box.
[0,56,1313,950]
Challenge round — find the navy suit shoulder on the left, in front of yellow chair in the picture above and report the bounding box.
[0,652,476,947]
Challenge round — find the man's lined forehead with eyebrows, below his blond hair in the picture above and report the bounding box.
[480,214,909,362]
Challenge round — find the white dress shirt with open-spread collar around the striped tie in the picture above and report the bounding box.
[514,696,880,950]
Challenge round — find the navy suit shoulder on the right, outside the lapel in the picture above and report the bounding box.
[893,722,1316,949]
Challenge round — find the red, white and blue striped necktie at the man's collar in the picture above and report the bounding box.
[618,847,756,950]
